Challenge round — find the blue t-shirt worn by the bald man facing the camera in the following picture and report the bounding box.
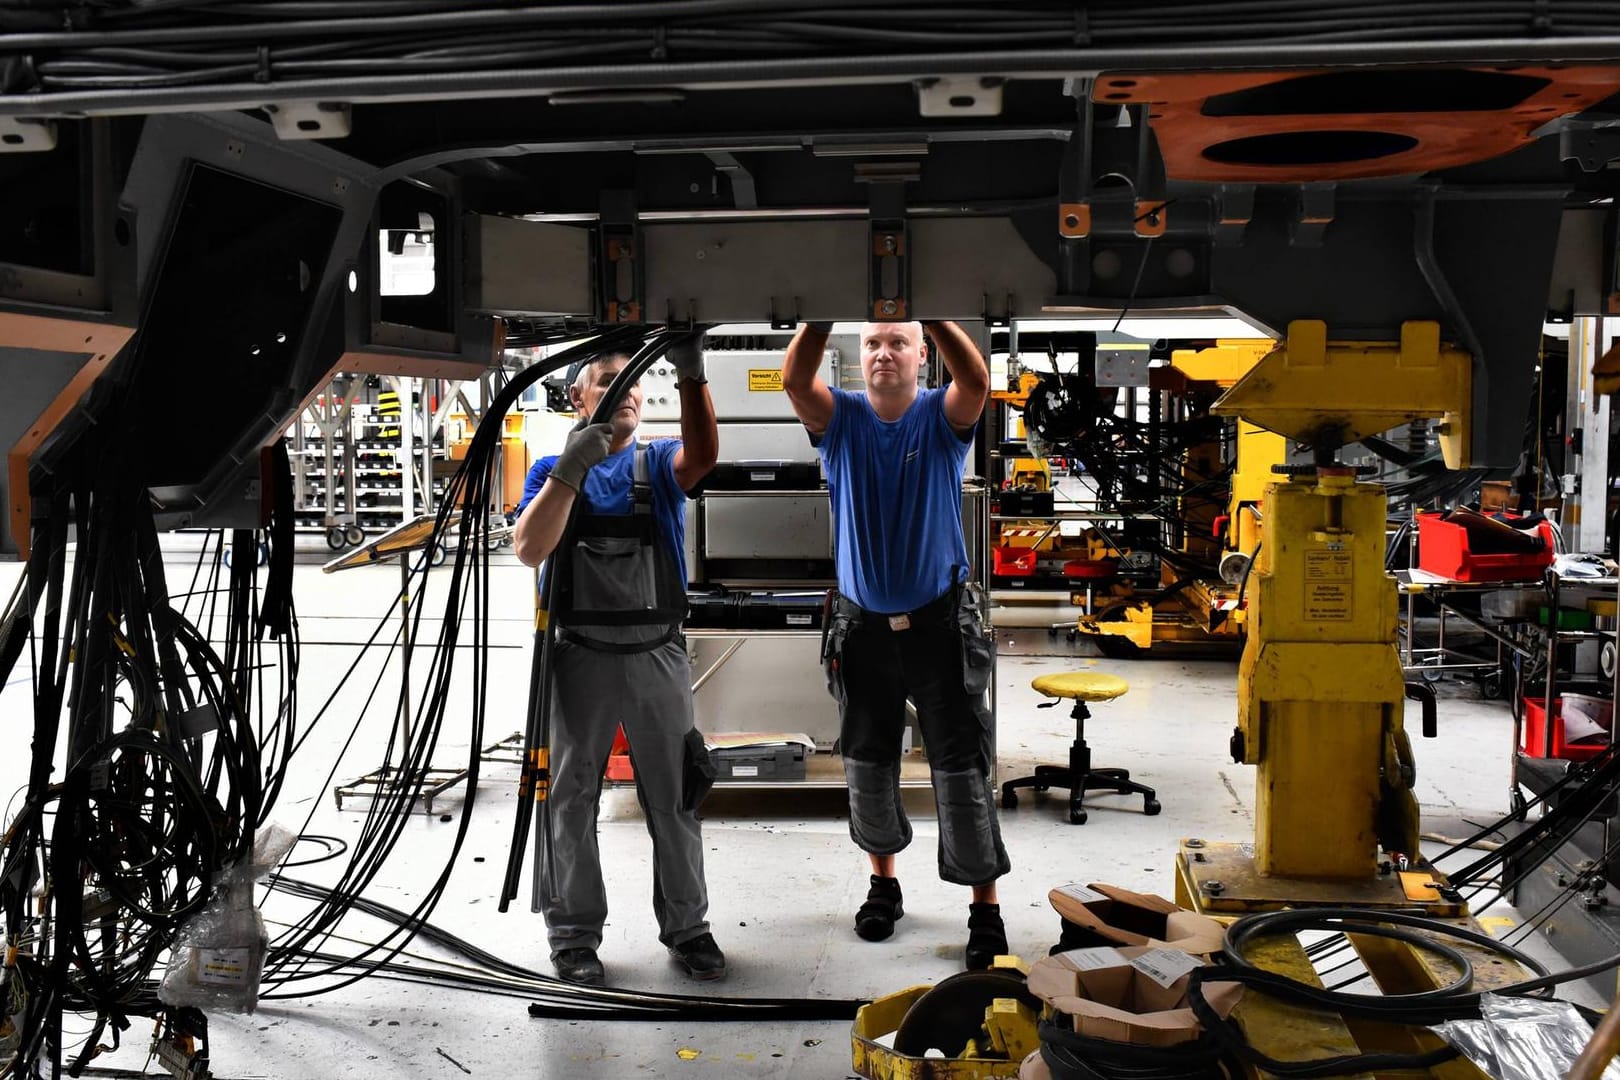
[815,390,972,614]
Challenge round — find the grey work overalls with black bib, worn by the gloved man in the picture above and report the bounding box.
[543,447,713,957]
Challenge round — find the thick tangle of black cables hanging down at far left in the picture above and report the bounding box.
[0,411,296,1075]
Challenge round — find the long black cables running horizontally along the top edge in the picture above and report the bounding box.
[9,0,1620,99]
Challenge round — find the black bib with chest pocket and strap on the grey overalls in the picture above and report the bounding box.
[552,447,687,653]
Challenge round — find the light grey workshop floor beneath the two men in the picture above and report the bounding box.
[0,536,1580,1080]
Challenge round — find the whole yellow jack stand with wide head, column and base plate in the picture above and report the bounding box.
[1176,322,1471,915]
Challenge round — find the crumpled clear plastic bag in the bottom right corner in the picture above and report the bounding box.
[1435,994,1620,1080]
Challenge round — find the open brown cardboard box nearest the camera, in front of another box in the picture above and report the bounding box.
[1029,946,1243,1046]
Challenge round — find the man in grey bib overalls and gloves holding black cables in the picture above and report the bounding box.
[514,338,726,984]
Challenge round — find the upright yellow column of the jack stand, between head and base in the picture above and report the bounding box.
[1233,466,1418,879]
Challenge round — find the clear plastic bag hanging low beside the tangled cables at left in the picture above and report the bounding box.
[157,826,298,1012]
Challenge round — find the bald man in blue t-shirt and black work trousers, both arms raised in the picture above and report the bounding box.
[782,322,1009,968]
